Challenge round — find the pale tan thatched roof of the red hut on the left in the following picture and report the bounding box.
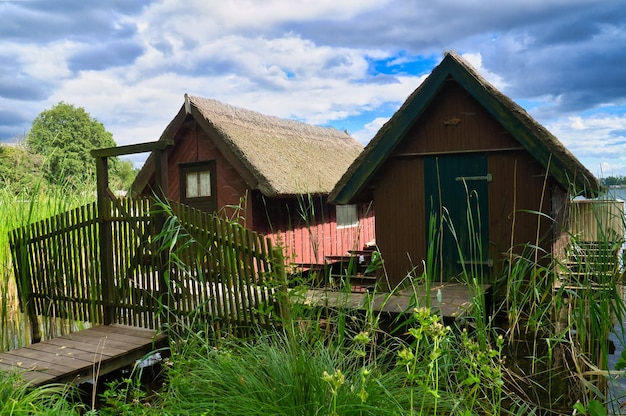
[133,95,363,197]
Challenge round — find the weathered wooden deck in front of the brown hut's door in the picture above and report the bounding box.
[305,283,491,320]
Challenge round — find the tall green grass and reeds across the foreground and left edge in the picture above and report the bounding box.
[0,177,624,415]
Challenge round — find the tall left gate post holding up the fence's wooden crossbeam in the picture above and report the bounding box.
[96,156,115,325]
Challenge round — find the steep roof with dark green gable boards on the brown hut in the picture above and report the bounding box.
[329,52,601,204]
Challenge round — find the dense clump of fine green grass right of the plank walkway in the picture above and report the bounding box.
[164,333,408,415]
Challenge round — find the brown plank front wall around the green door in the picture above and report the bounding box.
[372,80,565,284]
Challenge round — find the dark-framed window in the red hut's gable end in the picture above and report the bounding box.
[179,161,217,212]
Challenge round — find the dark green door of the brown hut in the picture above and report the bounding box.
[424,154,491,281]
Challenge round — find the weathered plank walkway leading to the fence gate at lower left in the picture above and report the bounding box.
[0,325,167,385]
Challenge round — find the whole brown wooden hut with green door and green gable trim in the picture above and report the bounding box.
[330,53,600,286]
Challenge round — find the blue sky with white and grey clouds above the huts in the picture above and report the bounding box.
[0,0,626,177]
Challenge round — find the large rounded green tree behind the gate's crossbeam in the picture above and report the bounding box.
[26,102,117,187]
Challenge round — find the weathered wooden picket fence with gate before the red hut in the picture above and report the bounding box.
[10,199,286,342]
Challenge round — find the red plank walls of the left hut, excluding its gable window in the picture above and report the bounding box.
[147,120,375,264]
